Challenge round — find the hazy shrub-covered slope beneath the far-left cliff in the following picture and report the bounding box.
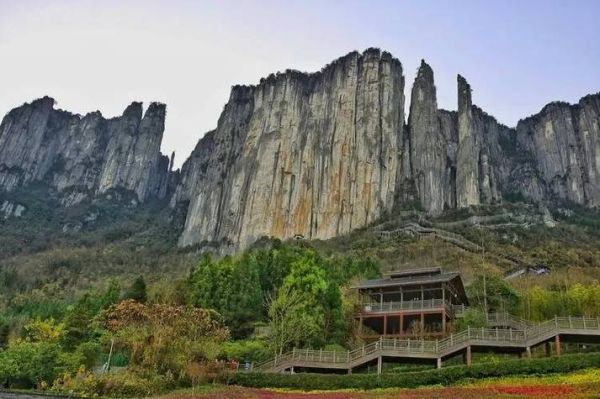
[0,187,197,308]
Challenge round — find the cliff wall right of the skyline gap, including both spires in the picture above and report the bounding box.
[171,50,600,250]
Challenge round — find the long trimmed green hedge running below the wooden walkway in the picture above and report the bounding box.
[233,353,600,390]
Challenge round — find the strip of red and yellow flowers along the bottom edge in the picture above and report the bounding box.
[156,369,600,399]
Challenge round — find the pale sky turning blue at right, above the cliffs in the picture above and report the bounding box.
[0,0,600,165]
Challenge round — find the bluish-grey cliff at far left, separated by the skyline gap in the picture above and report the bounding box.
[0,97,168,205]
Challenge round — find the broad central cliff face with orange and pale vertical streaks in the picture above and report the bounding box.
[178,50,404,248]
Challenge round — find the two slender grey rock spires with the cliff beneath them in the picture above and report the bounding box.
[408,66,512,214]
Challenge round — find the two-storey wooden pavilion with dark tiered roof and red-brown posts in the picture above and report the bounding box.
[354,267,468,340]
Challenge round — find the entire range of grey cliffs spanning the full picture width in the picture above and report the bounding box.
[0,49,600,251]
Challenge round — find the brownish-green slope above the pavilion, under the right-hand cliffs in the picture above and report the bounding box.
[314,204,600,286]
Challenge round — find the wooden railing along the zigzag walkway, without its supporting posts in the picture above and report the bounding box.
[253,314,600,370]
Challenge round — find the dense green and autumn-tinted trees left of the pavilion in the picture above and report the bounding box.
[0,242,379,396]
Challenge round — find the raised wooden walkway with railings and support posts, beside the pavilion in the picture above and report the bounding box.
[253,317,600,373]
